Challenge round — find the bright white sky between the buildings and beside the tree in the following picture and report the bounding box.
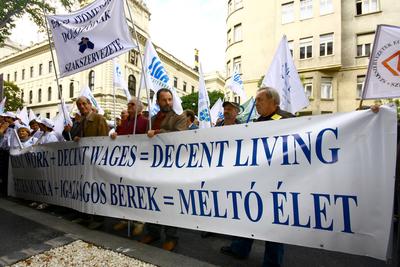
[11,0,226,72]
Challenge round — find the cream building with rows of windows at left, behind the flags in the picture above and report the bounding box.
[0,0,224,118]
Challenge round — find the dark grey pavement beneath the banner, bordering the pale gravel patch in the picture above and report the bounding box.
[0,199,397,267]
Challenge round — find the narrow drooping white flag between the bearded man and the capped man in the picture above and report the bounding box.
[197,64,211,129]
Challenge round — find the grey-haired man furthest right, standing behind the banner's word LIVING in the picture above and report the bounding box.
[221,87,294,266]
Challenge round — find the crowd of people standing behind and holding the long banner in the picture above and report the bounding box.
[0,87,398,266]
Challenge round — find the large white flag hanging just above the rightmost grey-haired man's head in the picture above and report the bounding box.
[262,35,309,114]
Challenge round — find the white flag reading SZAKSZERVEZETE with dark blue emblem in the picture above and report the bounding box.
[46,0,137,77]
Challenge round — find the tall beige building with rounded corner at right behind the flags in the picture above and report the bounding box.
[225,0,400,114]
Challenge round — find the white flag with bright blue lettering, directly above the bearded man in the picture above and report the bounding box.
[140,38,183,115]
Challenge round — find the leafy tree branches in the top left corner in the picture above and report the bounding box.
[0,0,76,45]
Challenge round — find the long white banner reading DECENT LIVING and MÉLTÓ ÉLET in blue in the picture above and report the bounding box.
[9,108,397,260]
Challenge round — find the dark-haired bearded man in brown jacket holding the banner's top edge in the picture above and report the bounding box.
[141,88,187,251]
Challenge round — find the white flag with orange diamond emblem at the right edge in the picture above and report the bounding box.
[362,25,400,99]
